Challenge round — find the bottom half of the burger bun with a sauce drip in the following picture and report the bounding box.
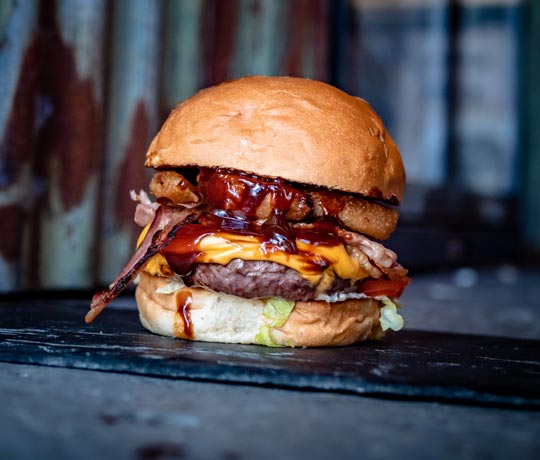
[135,272,383,347]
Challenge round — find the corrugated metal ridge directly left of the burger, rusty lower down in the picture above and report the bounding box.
[99,0,161,283]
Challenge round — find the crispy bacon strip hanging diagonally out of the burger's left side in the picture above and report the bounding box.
[84,206,199,324]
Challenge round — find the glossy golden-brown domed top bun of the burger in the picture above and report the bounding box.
[145,76,405,203]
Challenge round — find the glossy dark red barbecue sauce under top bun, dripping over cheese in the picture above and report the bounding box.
[161,168,341,276]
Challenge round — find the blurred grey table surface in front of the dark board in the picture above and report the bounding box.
[0,363,540,460]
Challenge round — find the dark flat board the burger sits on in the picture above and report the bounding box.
[0,299,540,408]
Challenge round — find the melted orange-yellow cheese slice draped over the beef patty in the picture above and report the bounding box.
[138,228,368,284]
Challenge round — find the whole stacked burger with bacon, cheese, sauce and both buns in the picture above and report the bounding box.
[86,76,409,347]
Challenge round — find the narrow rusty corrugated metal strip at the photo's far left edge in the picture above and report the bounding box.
[0,0,38,291]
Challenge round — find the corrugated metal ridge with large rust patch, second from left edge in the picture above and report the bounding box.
[31,0,106,288]
